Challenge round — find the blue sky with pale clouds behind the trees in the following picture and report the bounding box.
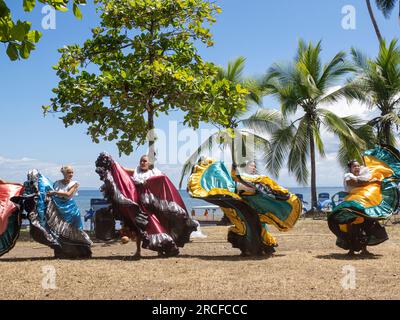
[0,0,400,187]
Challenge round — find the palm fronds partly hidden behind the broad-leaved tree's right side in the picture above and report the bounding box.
[179,57,280,188]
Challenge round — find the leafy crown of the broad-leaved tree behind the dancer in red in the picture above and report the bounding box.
[45,0,247,156]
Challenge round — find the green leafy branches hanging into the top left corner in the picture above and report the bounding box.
[0,0,86,60]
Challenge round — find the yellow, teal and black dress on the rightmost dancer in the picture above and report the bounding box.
[328,146,400,251]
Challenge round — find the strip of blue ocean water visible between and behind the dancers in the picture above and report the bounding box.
[75,187,343,220]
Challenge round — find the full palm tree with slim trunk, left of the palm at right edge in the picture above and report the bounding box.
[245,40,373,207]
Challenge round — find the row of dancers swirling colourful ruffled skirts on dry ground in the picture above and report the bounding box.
[0,146,400,258]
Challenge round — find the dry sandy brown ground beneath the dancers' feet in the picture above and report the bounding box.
[0,219,400,300]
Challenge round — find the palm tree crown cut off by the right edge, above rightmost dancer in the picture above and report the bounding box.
[349,40,400,146]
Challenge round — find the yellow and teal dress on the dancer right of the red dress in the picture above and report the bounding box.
[188,159,302,255]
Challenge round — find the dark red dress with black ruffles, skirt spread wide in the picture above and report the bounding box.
[96,153,196,256]
